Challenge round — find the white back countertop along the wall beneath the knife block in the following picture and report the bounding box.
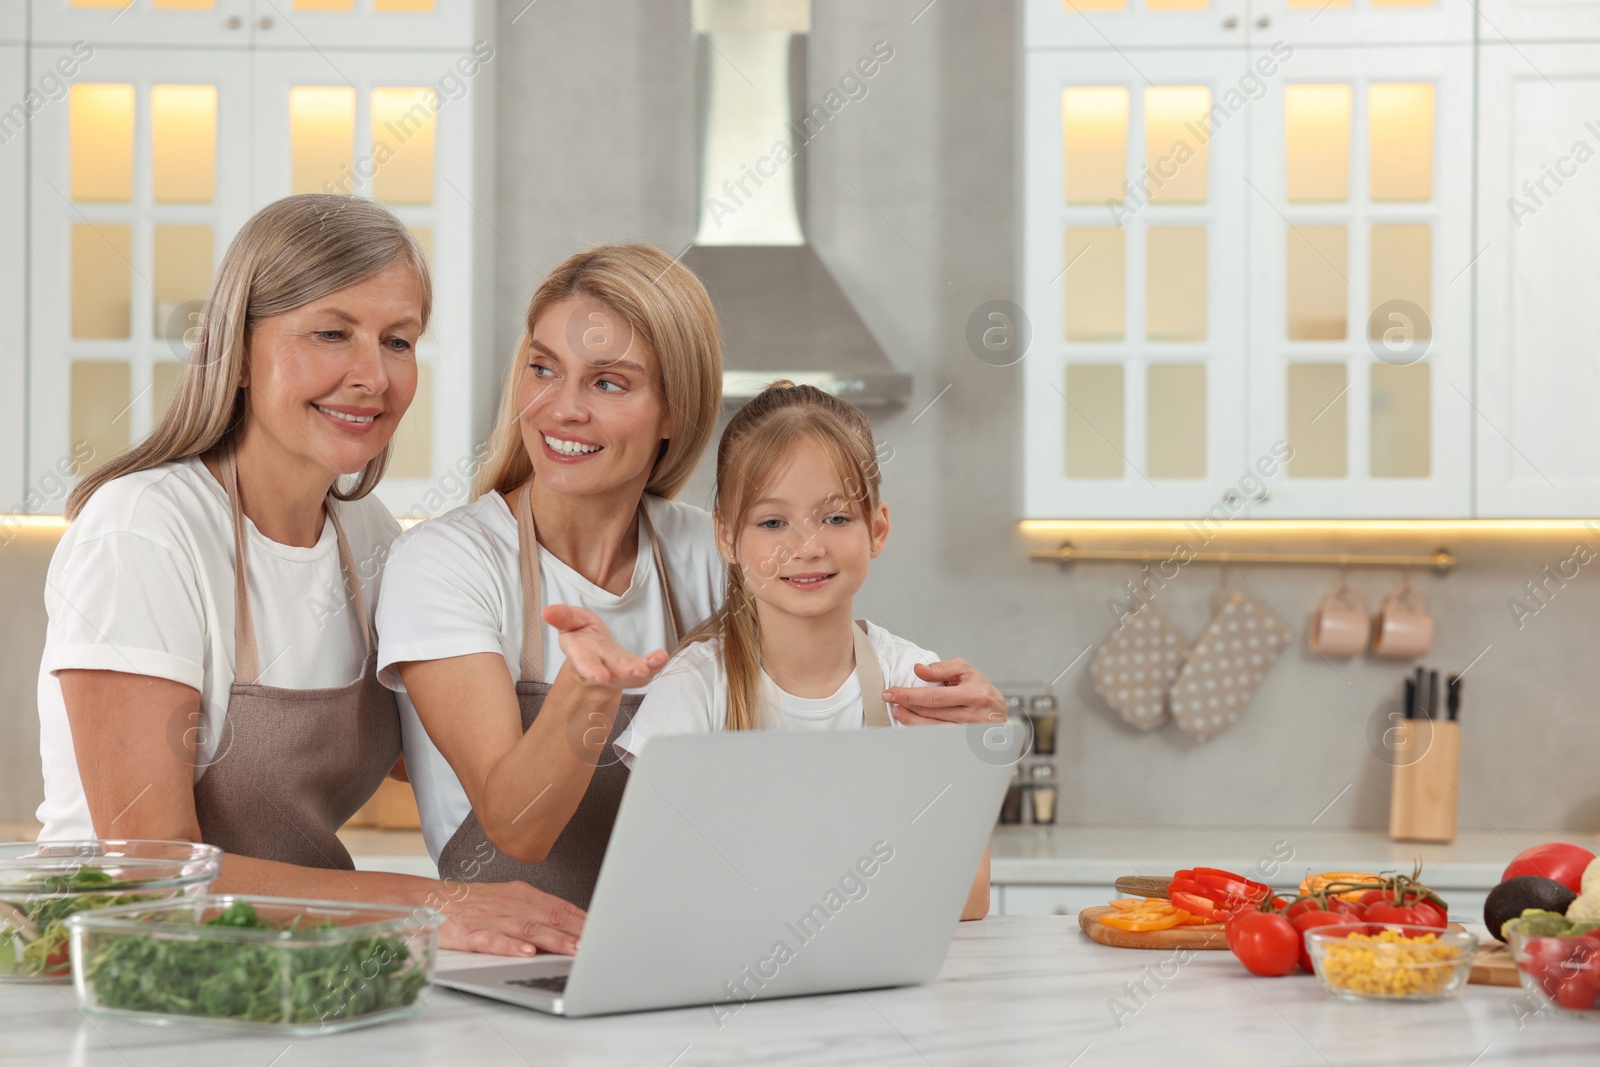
[990,825,1600,889]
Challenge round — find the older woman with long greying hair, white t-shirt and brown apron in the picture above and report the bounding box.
[38,195,582,953]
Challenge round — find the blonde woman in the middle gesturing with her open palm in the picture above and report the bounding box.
[378,245,1003,907]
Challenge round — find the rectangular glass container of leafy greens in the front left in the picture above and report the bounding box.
[67,894,445,1037]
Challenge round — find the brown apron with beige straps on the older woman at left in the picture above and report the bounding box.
[195,450,400,870]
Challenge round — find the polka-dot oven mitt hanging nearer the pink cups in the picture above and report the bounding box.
[1168,593,1290,741]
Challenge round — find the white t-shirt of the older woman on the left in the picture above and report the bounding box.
[38,458,400,838]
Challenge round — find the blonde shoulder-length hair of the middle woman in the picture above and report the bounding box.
[472,243,722,499]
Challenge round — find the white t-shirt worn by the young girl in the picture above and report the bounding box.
[616,622,939,766]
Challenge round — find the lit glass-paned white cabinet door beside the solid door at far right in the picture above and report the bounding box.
[1248,43,1474,518]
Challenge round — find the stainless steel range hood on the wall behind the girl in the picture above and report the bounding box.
[683,0,910,410]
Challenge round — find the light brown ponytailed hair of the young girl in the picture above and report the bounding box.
[683,381,880,729]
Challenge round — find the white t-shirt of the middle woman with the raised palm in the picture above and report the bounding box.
[378,493,726,873]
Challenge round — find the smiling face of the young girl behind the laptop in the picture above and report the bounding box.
[717,435,890,617]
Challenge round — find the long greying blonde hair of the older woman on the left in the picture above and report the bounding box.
[67,192,434,518]
